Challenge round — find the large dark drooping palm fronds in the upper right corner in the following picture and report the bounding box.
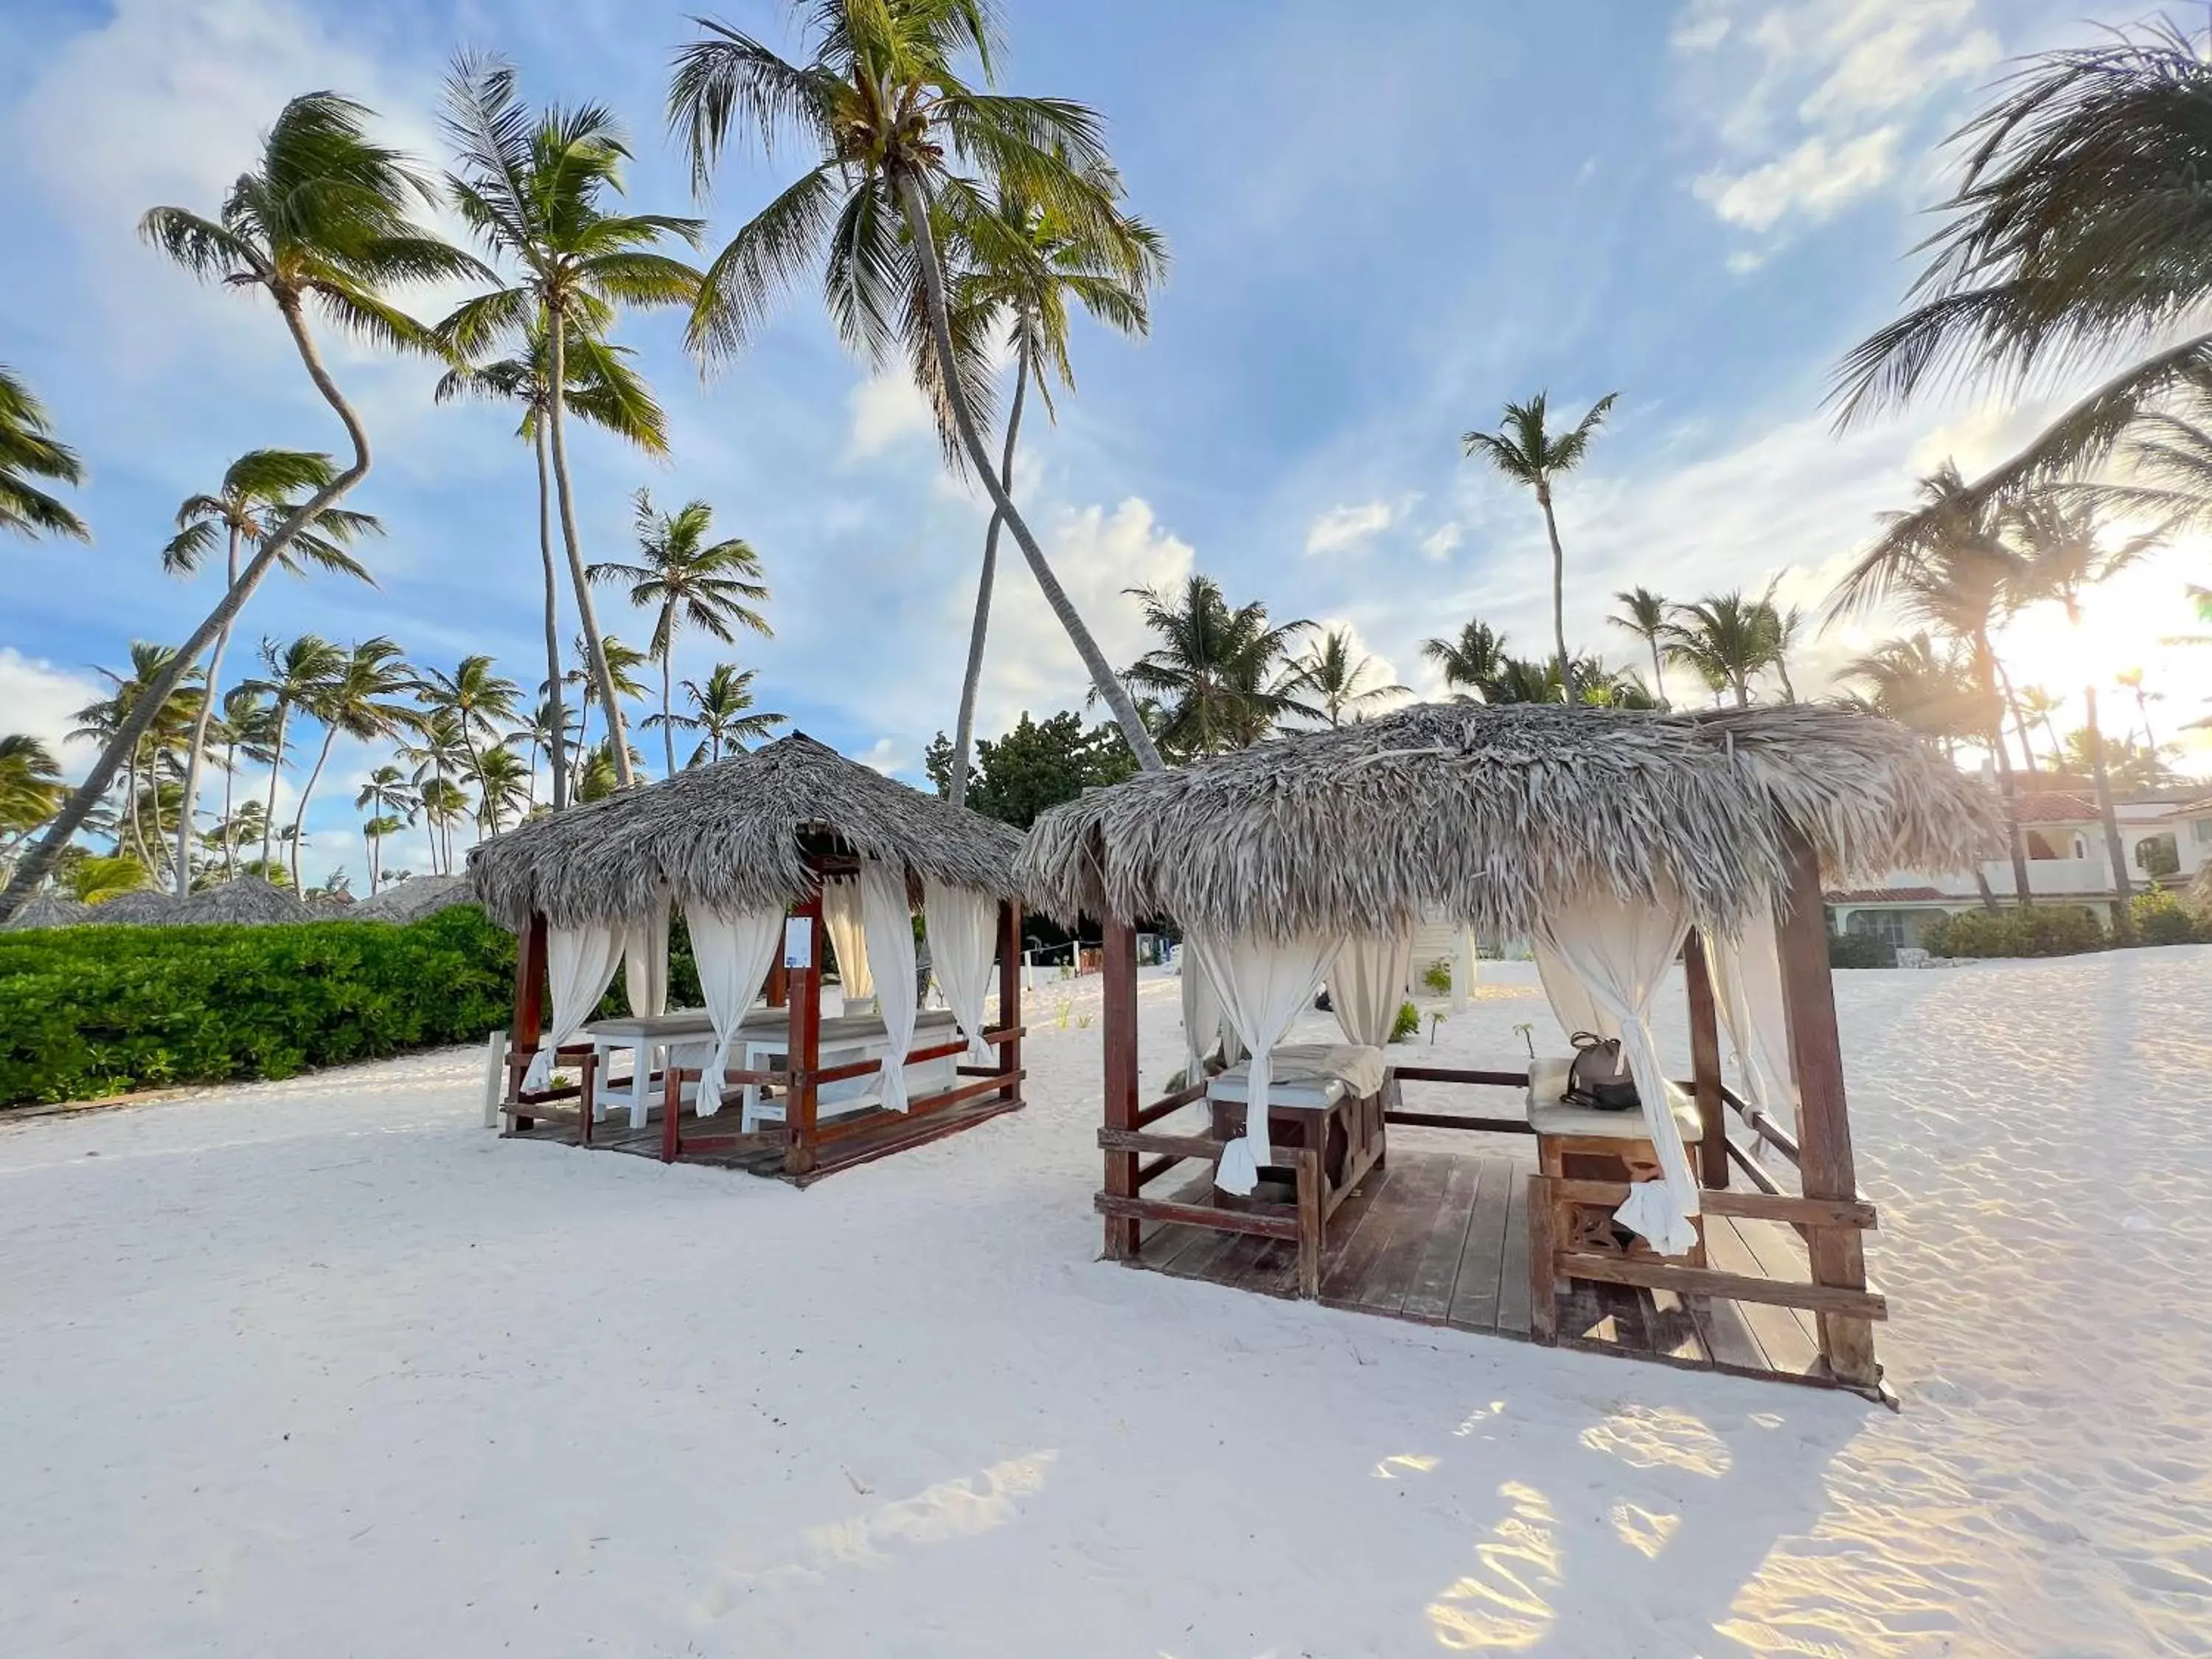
[1832,18,2212,504]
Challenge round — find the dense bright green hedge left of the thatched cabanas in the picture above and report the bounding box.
[0,905,522,1106]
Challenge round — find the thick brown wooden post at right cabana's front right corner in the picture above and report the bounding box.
[1776,827,1882,1389]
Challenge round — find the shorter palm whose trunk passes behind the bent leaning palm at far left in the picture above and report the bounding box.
[161,449,383,898]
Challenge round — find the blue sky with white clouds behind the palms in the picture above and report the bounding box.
[0,0,2212,885]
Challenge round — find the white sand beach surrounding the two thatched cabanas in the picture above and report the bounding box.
[0,949,2212,1659]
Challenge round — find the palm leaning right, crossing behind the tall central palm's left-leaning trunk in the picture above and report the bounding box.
[940,170,1168,807]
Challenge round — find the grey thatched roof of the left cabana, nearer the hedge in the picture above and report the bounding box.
[469,732,1022,929]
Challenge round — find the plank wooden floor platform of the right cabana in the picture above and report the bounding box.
[1135,1148,1836,1387]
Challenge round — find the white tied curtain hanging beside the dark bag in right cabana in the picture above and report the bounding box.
[1537,889,1699,1256]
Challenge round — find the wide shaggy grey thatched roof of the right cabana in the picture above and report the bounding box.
[1018,703,2002,938]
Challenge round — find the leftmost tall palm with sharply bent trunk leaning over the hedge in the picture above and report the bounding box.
[0,93,480,938]
